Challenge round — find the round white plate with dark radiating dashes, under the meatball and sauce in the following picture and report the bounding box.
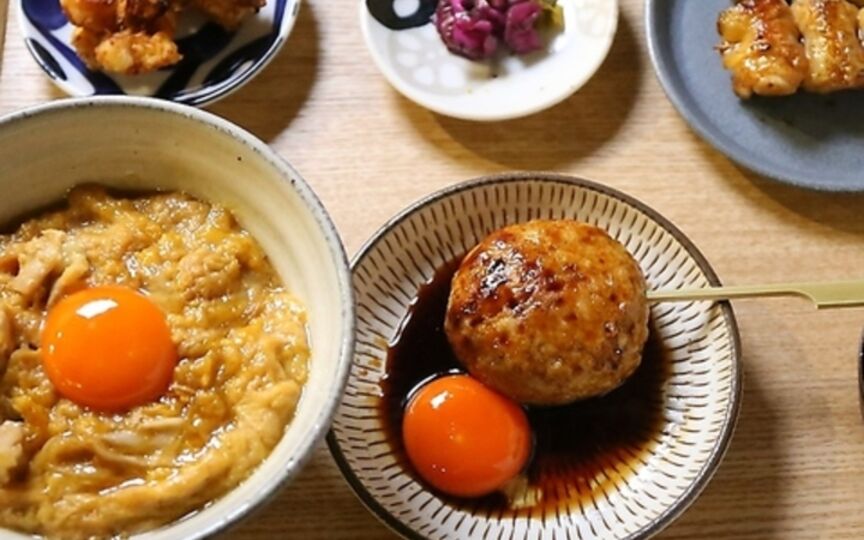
[328,174,741,540]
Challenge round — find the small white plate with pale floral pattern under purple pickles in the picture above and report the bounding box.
[360,0,618,121]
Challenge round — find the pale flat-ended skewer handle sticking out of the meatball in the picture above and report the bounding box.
[648,280,864,309]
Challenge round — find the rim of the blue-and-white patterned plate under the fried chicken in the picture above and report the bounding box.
[15,0,303,107]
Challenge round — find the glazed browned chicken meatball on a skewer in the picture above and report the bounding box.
[444,220,648,405]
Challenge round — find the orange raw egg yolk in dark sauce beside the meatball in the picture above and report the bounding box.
[402,375,531,497]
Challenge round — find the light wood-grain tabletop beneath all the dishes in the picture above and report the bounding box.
[0,0,864,540]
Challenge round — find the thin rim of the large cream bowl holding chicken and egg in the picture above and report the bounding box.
[0,96,356,540]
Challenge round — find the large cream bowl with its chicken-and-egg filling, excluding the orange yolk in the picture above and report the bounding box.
[0,98,353,539]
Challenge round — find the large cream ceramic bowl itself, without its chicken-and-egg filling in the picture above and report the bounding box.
[0,98,354,540]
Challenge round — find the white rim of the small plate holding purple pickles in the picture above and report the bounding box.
[360,0,621,122]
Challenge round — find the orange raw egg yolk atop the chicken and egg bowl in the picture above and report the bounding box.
[42,286,177,412]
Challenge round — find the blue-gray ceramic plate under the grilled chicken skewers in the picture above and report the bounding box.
[645,0,864,191]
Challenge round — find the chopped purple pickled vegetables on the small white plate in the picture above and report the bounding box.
[435,0,554,60]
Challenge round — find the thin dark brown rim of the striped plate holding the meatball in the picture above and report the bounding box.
[327,172,744,540]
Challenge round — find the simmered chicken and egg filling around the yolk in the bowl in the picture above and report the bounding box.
[0,187,309,538]
